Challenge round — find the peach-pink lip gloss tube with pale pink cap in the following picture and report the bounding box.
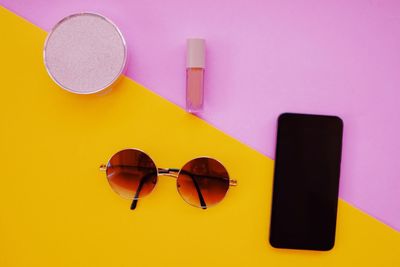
[186,38,206,113]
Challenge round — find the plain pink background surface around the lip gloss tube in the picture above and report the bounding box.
[0,0,400,230]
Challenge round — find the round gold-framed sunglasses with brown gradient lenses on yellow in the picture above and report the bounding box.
[100,149,237,210]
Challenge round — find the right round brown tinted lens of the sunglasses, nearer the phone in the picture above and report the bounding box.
[177,158,229,208]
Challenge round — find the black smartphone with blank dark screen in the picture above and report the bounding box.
[269,113,343,251]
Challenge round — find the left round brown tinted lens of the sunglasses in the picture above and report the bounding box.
[106,149,157,199]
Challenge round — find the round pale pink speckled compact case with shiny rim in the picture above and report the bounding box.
[43,13,127,94]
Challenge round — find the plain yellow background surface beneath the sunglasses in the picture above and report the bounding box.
[0,8,400,267]
